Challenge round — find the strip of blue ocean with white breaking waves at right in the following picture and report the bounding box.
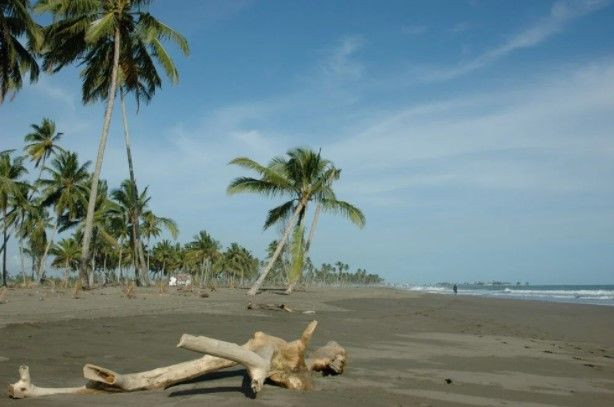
[399,284,614,306]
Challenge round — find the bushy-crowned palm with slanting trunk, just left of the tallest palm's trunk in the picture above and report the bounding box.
[38,152,90,280]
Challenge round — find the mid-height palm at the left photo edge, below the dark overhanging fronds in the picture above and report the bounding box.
[0,151,28,286]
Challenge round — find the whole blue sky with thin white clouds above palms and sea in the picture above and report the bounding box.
[0,0,614,283]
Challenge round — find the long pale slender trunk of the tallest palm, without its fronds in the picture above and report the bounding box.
[79,29,121,288]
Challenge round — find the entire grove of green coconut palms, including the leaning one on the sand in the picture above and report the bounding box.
[0,0,381,294]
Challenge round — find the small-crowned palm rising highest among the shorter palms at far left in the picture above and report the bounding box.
[24,117,64,181]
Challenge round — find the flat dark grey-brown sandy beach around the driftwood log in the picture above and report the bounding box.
[0,288,614,406]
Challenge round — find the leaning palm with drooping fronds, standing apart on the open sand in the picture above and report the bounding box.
[228,148,365,295]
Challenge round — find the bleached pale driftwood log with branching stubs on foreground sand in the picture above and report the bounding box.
[8,321,346,399]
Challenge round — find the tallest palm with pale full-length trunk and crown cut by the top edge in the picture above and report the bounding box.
[37,0,187,285]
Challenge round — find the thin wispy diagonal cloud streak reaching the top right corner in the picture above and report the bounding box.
[422,0,610,82]
